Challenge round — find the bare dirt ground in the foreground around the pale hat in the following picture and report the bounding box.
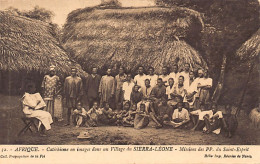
[0,95,260,145]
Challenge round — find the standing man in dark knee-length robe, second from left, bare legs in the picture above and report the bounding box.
[64,68,83,125]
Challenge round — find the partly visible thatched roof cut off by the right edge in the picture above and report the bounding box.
[236,28,260,60]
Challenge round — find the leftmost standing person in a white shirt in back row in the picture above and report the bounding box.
[122,73,135,102]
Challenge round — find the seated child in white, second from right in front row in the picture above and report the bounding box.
[203,103,223,134]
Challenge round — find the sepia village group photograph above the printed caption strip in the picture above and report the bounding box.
[0,0,260,163]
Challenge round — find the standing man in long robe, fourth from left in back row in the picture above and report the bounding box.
[98,68,115,108]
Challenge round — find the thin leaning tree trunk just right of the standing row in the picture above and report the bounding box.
[212,54,227,103]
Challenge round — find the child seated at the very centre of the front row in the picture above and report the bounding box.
[134,104,149,129]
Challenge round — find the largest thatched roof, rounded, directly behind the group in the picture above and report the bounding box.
[63,7,206,72]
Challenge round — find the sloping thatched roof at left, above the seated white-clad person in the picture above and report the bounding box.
[0,11,86,76]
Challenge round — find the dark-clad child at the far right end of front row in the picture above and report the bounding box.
[223,105,238,138]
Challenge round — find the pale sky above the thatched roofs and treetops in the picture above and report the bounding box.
[0,0,155,26]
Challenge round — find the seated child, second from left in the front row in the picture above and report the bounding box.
[86,101,102,127]
